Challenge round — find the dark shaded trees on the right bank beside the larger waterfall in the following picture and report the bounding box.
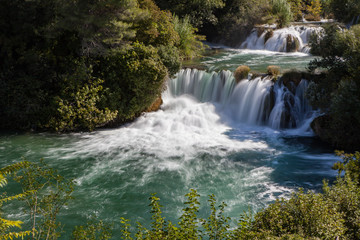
[307,26,360,149]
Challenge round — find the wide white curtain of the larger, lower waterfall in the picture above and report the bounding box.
[168,69,312,129]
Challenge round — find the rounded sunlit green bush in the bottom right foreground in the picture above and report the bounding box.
[253,190,345,239]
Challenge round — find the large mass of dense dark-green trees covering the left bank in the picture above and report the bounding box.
[0,0,202,131]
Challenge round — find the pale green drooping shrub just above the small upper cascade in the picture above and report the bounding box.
[272,0,293,28]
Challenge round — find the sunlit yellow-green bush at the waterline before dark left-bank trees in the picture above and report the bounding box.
[48,62,117,132]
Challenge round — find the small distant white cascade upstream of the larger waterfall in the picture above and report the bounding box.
[240,25,323,53]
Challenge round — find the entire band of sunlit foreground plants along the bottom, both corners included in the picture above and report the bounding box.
[0,152,360,240]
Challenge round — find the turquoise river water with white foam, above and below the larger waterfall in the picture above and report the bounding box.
[0,49,339,239]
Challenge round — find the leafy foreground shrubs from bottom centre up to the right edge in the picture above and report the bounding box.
[122,152,360,240]
